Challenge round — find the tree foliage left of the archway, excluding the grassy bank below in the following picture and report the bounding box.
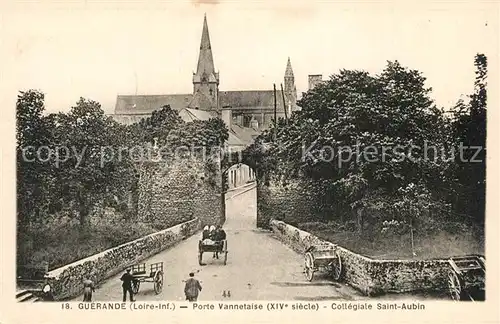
[17,98,228,230]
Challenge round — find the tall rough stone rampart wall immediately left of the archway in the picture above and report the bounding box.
[138,155,224,227]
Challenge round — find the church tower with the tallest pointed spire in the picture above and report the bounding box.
[188,15,219,110]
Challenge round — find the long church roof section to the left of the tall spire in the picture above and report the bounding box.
[115,94,193,115]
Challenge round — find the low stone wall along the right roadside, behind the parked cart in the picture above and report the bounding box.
[269,220,449,296]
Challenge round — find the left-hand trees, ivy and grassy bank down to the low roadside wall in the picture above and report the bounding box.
[16,97,229,267]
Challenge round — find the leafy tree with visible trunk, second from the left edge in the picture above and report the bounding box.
[48,98,130,230]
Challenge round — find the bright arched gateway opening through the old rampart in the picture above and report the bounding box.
[224,163,257,231]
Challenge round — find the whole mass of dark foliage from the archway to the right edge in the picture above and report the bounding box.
[244,55,486,238]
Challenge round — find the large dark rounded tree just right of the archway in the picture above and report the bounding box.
[246,61,448,231]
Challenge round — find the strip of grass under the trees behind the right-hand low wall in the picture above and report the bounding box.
[299,223,484,260]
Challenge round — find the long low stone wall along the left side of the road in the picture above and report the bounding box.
[47,219,199,300]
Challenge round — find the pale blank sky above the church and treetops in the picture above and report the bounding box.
[0,0,498,113]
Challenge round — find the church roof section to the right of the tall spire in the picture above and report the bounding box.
[219,90,284,112]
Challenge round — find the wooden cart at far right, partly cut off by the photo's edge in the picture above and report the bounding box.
[448,255,486,301]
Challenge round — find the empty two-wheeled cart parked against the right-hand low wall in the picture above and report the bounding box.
[304,243,342,281]
